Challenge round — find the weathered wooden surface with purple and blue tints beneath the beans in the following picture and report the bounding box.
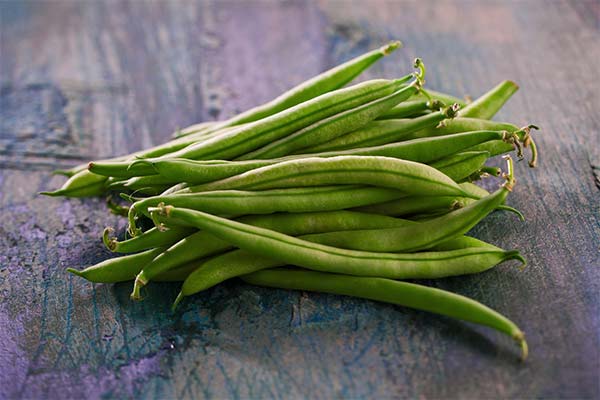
[0,1,600,398]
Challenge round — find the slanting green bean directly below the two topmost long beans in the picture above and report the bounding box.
[237,84,419,160]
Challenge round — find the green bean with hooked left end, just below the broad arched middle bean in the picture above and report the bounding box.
[129,185,405,236]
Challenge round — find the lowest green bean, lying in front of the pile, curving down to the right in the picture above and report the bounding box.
[242,269,528,360]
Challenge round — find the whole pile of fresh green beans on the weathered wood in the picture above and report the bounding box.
[48,42,538,358]
